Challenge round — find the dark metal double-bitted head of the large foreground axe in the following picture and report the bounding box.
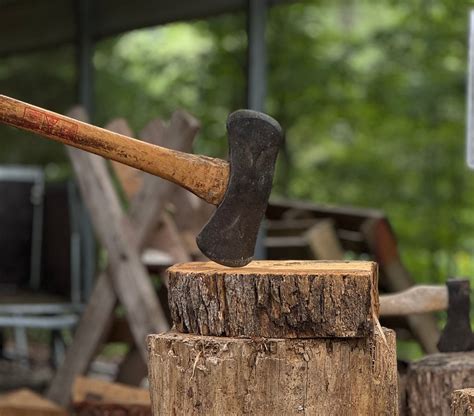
[196,110,283,267]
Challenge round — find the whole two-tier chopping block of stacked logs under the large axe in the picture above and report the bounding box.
[148,261,398,416]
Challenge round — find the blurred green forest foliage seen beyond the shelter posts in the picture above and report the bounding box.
[0,0,474,410]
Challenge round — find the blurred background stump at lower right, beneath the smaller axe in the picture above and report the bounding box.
[407,352,474,416]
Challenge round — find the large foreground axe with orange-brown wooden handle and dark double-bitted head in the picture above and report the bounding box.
[0,95,282,267]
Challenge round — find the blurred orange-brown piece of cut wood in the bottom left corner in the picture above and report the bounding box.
[0,389,68,416]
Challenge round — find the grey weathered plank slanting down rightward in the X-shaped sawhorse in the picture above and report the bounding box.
[67,107,168,357]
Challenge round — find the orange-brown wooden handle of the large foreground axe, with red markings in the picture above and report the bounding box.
[0,95,230,205]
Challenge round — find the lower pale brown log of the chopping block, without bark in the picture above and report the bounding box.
[148,330,398,416]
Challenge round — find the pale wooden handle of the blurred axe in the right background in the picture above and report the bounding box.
[380,285,448,316]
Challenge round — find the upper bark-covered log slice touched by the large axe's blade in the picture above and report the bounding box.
[168,261,378,338]
